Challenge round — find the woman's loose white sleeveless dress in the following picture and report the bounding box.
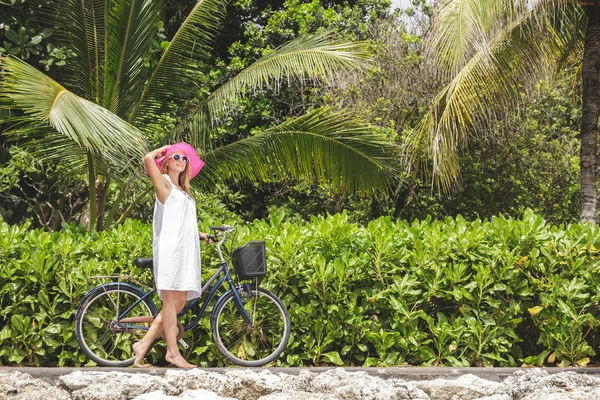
[152,174,202,300]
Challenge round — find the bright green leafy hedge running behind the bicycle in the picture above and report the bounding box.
[0,212,600,366]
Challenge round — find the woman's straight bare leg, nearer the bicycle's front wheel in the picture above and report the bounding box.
[161,290,196,368]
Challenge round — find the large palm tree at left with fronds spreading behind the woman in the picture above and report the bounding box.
[0,0,394,229]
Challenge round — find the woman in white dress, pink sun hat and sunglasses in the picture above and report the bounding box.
[133,142,208,368]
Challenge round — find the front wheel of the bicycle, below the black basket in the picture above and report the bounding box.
[211,288,291,367]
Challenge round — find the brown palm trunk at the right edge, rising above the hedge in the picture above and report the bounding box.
[579,5,600,223]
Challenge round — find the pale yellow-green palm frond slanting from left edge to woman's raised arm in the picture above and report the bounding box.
[0,57,147,166]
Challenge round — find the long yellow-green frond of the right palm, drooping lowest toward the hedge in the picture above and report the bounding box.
[405,0,576,191]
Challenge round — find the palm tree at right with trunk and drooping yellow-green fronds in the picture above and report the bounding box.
[408,0,600,222]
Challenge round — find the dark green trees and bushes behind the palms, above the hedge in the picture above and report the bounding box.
[0,0,592,230]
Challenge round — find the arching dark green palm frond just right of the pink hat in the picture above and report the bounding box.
[199,109,398,194]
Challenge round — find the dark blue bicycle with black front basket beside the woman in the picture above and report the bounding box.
[75,225,291,367]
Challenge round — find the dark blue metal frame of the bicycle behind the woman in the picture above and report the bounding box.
[97,230,252,331]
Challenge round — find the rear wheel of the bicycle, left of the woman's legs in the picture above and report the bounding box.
[75,283,156,367]
